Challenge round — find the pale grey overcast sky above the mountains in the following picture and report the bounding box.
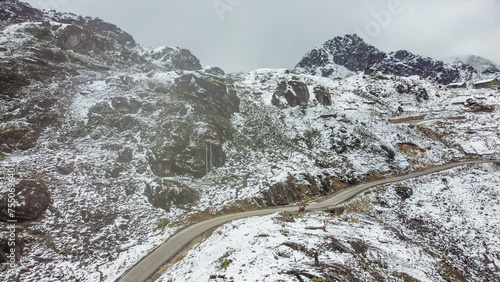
[22,0,500,72]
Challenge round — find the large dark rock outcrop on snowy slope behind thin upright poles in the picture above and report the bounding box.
[148,73,239,177]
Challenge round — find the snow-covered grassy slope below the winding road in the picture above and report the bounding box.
[157,164,500,281]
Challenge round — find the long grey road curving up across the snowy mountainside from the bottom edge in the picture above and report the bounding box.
[117,160,496,282]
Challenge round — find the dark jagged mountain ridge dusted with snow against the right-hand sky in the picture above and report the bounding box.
[293,34,490,84]
